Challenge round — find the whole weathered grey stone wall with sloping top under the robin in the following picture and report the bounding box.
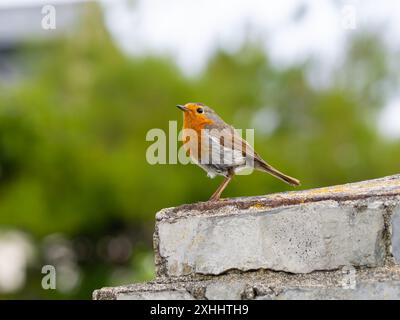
[93,175,400,299]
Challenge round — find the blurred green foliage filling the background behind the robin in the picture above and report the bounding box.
[0,5,400,298]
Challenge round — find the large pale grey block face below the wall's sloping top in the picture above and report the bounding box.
[158,200,385,276]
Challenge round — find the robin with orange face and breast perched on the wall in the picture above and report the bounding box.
[177,103,300,201]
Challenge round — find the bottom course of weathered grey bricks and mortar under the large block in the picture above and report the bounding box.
[93,266,400,300]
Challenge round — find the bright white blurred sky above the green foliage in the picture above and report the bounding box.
[0,0,400,138]
